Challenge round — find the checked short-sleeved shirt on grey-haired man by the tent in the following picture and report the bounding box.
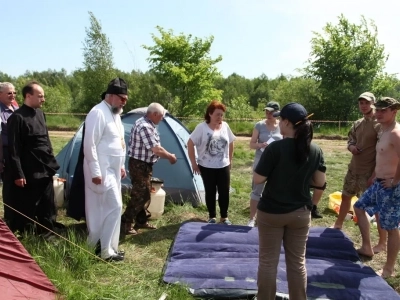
[128,116,160,164]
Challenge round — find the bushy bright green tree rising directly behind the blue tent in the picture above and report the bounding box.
[143,26,222,117]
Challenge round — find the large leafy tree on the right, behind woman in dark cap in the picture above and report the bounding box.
[304,15,387,120]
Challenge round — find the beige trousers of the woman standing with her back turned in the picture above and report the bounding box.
[257,207,311,300]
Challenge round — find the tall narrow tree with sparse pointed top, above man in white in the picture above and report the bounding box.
[79,12,116,112]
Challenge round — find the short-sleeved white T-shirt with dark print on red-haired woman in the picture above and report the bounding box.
[190,122,236,169]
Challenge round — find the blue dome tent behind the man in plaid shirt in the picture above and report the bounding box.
[56,108,205,205]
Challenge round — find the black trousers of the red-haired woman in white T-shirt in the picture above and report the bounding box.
[199,165,231,218]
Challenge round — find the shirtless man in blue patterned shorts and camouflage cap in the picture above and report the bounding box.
[354,97,400,278]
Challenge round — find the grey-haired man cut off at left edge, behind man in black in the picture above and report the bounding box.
[0,82,18,221]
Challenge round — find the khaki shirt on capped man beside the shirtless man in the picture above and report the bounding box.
[347,117,380,174]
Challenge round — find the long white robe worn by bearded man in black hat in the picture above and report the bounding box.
[83,101,126,259]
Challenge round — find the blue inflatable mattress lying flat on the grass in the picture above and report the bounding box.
[163,222,400,300]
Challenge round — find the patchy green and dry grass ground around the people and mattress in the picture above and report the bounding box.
[0,135,400,300]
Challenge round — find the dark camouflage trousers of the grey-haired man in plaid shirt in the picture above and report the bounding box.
[121,157,153,224]
